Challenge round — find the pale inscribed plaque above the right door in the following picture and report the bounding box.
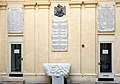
[98,2,115,32]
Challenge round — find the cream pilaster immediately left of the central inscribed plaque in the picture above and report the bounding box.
[36,3,50,73]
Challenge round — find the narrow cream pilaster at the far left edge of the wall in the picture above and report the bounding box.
[0,3,8,75]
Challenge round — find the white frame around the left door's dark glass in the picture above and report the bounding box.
[8,37,23,76]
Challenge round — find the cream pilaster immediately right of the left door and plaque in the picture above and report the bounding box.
[24,6,35,74]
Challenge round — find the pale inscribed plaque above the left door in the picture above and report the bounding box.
[8,8,23,33]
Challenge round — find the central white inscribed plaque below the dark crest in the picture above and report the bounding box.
[52,20,68,51]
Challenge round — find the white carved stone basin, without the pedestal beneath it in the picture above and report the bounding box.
[43,63,70,76]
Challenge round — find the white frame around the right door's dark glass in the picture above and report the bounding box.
[97,35,115,79]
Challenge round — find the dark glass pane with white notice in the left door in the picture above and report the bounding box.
[11,44,21,72]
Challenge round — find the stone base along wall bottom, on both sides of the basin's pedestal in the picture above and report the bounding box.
[0,75,120,84]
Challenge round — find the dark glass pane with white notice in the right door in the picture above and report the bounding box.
[100,43,112,72]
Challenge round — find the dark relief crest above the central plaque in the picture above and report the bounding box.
[54,4,66,17]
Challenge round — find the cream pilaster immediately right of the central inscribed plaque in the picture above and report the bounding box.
[68,5,81,75]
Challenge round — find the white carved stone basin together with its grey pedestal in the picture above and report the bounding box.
[43,63,70,84]
